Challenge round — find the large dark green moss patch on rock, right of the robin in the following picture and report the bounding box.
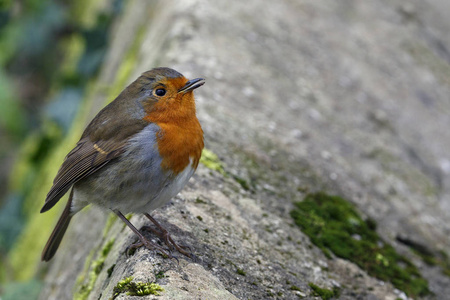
[291,193,430,297]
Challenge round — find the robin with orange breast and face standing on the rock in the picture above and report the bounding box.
[41,68,205,261]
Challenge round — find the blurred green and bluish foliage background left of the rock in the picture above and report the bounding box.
[0,0,124,300]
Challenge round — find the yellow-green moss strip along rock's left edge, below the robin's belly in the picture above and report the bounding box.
[73,238,115,300]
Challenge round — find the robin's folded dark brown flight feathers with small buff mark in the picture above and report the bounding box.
[41,137,125,213]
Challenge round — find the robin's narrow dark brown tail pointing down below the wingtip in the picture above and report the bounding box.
[41,189,73,261]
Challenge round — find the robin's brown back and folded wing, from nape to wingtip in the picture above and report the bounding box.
[41,73,152,212]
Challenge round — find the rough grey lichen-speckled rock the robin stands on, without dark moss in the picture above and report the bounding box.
[37,0,450,299]
